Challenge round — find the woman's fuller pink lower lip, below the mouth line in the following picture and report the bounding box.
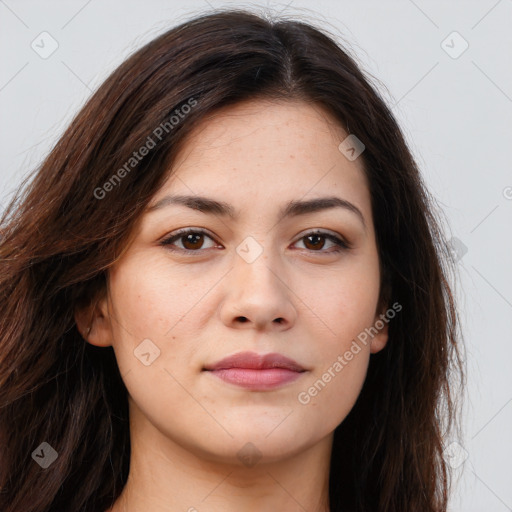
[206,368,304,390]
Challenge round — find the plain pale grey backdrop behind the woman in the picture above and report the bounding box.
[0,0,512,512]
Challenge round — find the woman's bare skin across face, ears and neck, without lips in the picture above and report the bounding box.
[75,100,388,512]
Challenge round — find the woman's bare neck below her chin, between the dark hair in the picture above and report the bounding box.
[109,402,332,512]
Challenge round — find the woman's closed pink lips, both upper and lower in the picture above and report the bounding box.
[204,352,306,391]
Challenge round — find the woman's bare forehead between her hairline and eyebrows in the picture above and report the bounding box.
[152,100,370,221]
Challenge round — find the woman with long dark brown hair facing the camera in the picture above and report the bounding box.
[0,10,463,512]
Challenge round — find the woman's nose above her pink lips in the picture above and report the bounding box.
[220,251,297,331]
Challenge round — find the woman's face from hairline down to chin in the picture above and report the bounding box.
[77,101,387,463]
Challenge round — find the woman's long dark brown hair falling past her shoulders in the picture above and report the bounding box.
[0,10,464,512]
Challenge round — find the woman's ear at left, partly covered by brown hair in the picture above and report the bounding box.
[75,294,112,347]
